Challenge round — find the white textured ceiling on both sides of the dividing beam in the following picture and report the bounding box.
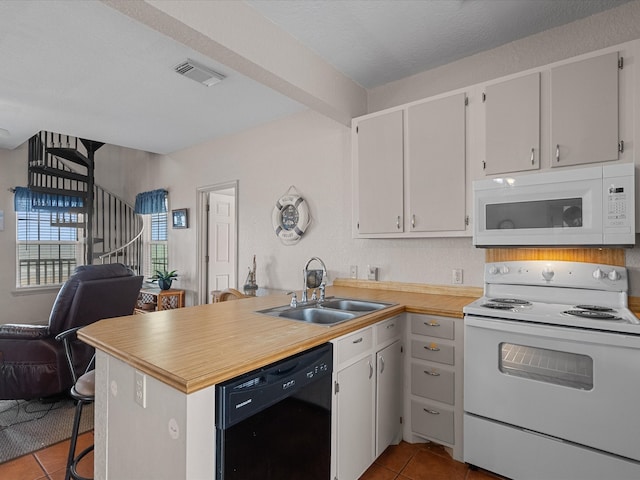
[0,0,626,153]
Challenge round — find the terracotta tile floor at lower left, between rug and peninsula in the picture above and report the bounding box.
[0,432,93,480]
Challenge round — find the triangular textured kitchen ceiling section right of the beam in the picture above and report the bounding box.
[247,0,628,88]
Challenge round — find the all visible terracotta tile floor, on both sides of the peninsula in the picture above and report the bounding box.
[0,432,501,480]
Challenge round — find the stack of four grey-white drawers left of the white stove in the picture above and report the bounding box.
[409,314,462,446]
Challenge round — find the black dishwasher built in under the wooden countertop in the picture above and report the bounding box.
[216,343,333,480]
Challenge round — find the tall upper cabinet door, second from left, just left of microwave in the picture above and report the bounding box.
[405,93,466,232]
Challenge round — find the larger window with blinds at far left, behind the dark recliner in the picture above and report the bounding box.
[16,210,82,288]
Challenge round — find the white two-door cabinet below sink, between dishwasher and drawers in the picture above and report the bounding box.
[331,316,403,480]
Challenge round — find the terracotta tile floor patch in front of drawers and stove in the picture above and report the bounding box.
[360,442,502,480]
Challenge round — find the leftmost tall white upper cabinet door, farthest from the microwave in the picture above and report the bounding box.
[354,110,404,234]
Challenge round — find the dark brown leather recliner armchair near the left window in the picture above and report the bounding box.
[0,264,142,400]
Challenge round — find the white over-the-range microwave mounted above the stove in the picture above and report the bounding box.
[473,163,635,247]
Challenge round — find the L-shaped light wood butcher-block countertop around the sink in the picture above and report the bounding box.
[78,280,482,394]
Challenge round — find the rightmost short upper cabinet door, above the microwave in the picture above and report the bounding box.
[551,52,619,167]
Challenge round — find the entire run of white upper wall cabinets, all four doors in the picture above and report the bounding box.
[352,40,640,238]
